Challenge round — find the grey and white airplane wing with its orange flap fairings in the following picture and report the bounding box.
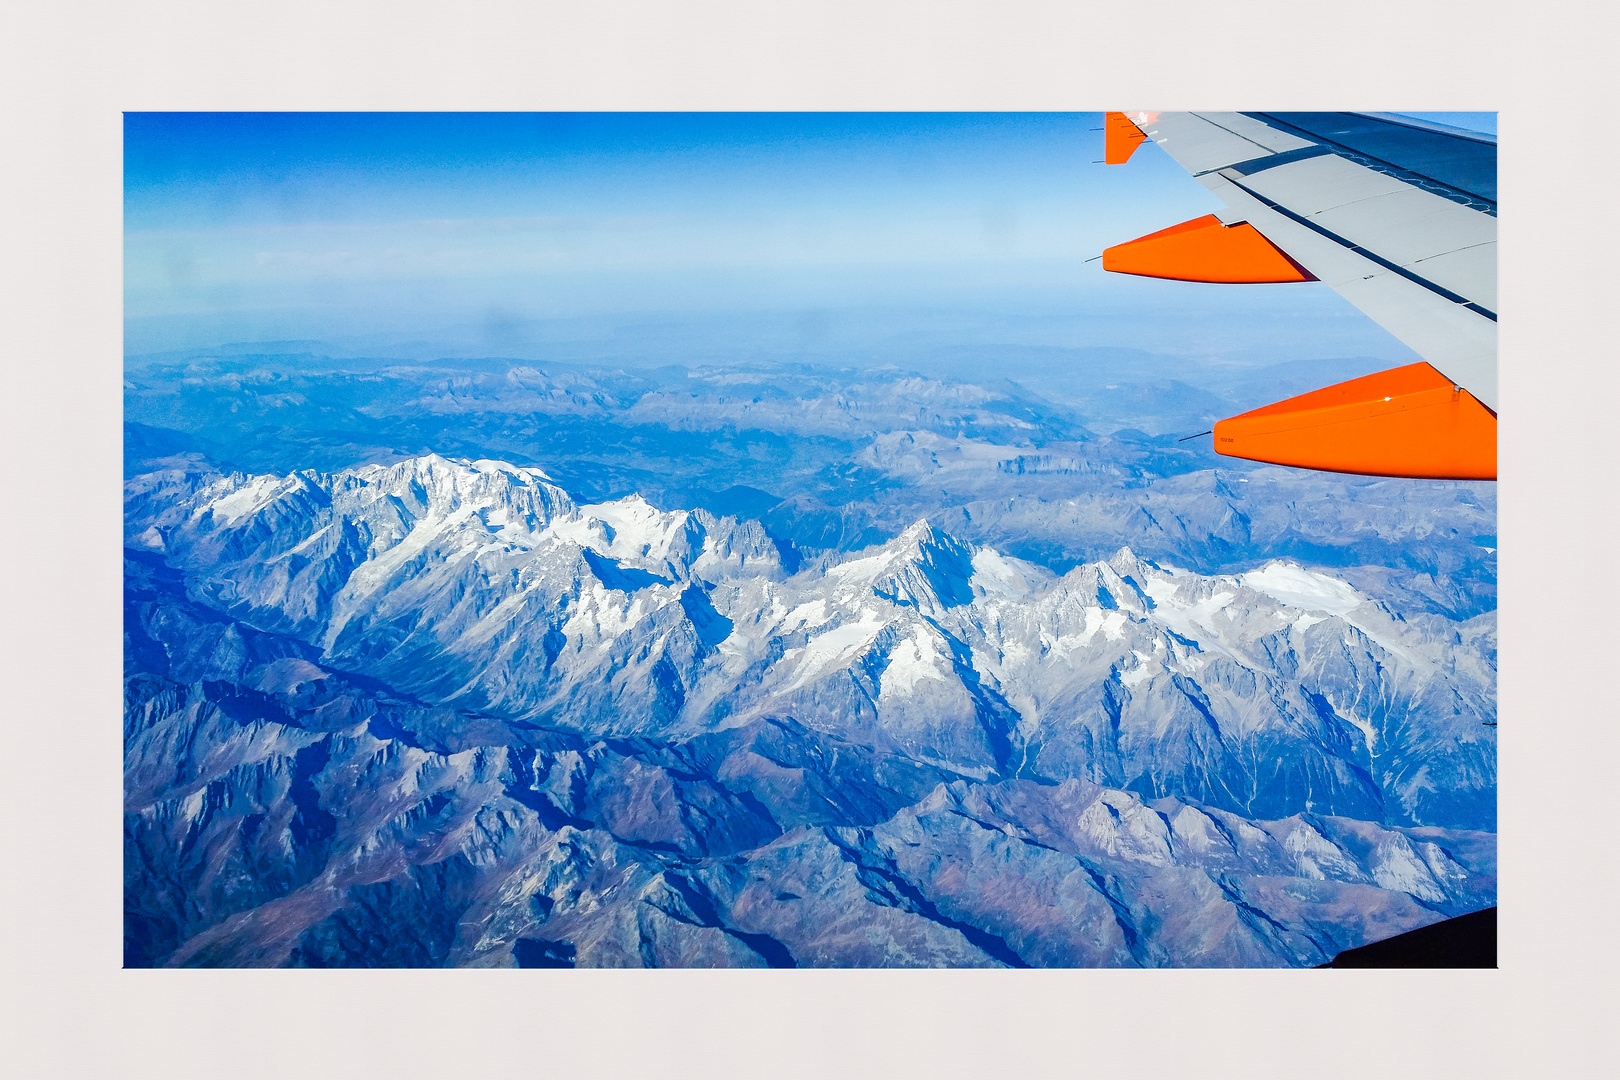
[1103,112,1497,479]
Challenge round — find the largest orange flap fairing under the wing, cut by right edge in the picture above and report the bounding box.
[1215,363,1497,479]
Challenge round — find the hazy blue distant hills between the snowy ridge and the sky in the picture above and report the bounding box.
[125,345,1497,617]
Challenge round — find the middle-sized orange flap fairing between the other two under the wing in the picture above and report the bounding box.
[1103,214,1317,283]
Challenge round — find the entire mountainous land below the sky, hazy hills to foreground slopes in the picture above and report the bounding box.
[125,335,1497,967]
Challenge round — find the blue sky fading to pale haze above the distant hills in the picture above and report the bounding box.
[125,113,1494,361]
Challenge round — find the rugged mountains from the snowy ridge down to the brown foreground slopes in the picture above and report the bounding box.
[125,455,1495,967]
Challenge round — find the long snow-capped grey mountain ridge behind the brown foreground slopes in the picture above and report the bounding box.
[126,458,1495,823]
